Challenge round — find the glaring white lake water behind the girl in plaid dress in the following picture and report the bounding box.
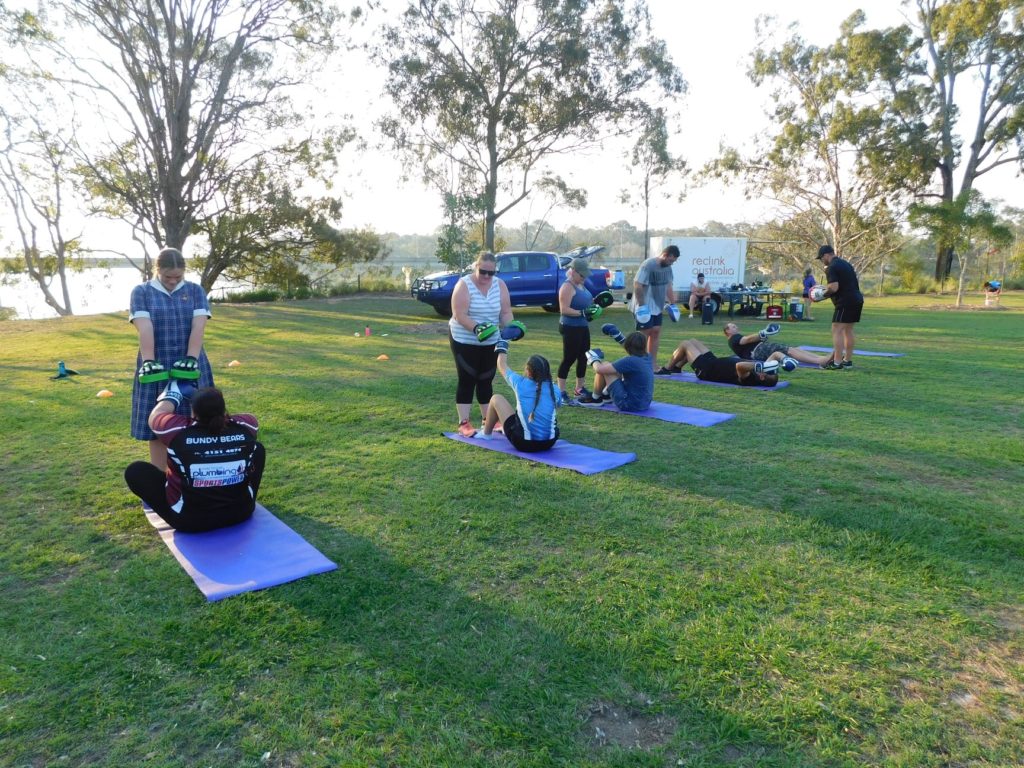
[0,266,241,319]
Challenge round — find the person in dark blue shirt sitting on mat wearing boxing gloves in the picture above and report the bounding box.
[578,323,654,411]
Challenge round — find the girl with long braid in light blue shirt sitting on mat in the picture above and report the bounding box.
[476,339,561,454]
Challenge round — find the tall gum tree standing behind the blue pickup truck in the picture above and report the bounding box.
[375,0,685,249]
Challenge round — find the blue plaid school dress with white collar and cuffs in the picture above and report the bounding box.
[128,279,213,440]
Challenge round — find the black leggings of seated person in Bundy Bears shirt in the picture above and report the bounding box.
[125,442,266,534]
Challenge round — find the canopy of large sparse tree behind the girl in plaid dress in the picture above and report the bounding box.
[20,0,348,271]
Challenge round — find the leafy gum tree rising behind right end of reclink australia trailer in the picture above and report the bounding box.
[703,18,909,269]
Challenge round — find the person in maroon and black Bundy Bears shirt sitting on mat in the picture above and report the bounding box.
[125,379,266,532]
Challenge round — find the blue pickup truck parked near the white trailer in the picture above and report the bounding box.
[412,246,623,317]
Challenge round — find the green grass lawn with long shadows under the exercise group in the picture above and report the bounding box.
[0,294,1024,768]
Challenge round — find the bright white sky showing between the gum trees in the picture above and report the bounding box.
[338,0,1024,233]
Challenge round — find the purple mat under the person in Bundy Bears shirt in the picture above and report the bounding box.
[145,504,338,602]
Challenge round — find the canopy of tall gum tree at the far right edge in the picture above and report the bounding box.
[834,0,1024,281]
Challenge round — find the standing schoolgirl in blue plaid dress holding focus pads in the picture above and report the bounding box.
[128,248,213,471]
